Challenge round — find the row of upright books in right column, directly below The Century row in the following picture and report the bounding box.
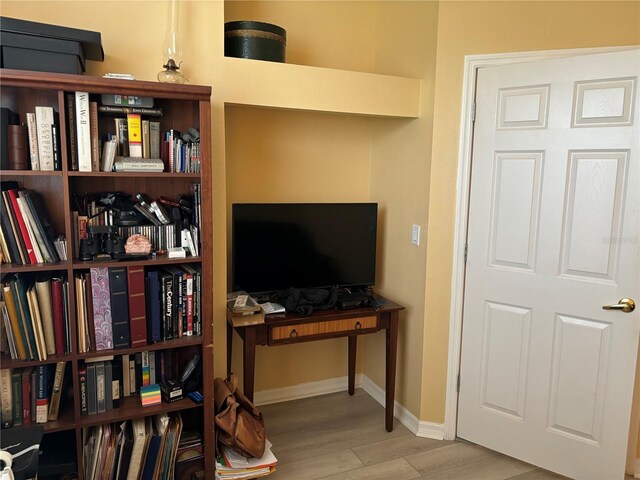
[78,350,185,415]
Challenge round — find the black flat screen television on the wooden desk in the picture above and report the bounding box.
[231,203,378,294]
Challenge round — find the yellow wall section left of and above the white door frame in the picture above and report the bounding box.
[420,1,640,423]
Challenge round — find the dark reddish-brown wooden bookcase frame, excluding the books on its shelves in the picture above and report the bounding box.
[0,69,215,480]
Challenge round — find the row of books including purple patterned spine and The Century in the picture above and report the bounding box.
[74,264,202,353]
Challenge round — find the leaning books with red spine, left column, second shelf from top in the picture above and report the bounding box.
[0,182,67,265]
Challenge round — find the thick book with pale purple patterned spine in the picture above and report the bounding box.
[90,268,114,350]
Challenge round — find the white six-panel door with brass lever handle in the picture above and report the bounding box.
[458,50,640,480]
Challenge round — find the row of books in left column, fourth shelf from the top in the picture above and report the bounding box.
[0,362,66,428]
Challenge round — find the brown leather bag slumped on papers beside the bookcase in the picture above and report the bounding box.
[213,374,266,458]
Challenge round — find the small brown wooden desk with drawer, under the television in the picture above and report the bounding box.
[227,297,404,432]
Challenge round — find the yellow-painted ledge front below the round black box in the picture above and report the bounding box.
[223,57,420,118]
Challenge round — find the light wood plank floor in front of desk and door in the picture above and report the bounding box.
[260,389,631,480]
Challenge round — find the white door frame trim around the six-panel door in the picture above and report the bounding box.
[444,45,640,454]
